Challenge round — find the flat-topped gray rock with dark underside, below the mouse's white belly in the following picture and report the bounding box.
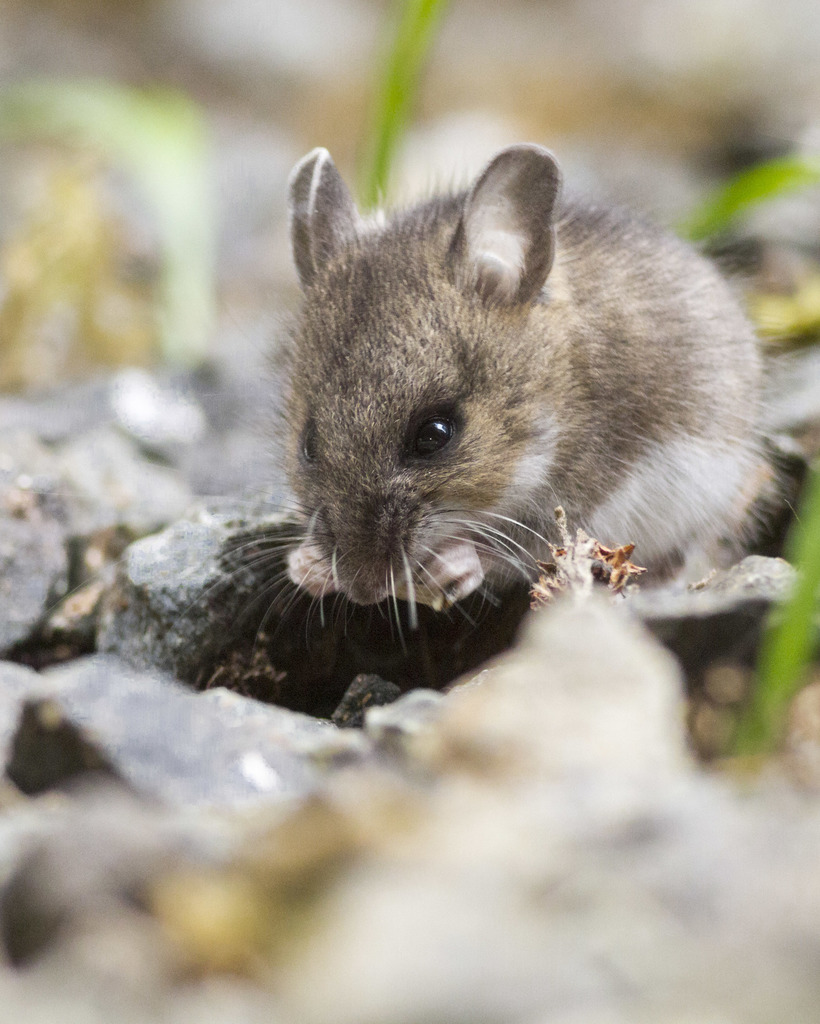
[627,555,794,689]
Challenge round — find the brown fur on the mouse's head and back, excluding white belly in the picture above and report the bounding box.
[284,148,759,599]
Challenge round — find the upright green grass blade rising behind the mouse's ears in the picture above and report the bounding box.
[359,0,447,208]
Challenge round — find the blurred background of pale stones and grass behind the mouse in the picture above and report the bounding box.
[0,0,820,490]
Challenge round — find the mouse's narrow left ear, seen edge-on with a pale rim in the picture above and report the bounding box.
[288,148,359,288]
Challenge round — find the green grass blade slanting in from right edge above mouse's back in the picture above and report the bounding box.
[681,156,820,242]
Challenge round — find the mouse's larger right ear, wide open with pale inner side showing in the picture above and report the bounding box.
[452,145,561,305]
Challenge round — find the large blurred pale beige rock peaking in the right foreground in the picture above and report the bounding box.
[276,602,820,1024]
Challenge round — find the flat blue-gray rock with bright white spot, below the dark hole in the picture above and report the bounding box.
[0,655,335,806]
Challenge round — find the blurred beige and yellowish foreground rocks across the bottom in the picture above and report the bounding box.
[0,600,820,1024]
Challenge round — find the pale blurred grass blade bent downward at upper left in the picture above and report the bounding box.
[0,80,216,365]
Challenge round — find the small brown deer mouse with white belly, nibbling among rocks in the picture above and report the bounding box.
[283,144,761,609]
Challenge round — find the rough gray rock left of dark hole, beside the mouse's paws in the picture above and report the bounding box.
[92,503,346,710]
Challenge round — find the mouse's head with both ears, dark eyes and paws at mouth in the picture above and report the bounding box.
[285,145,560,606]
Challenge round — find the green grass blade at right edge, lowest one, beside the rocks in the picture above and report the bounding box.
[733,470,820,756]
